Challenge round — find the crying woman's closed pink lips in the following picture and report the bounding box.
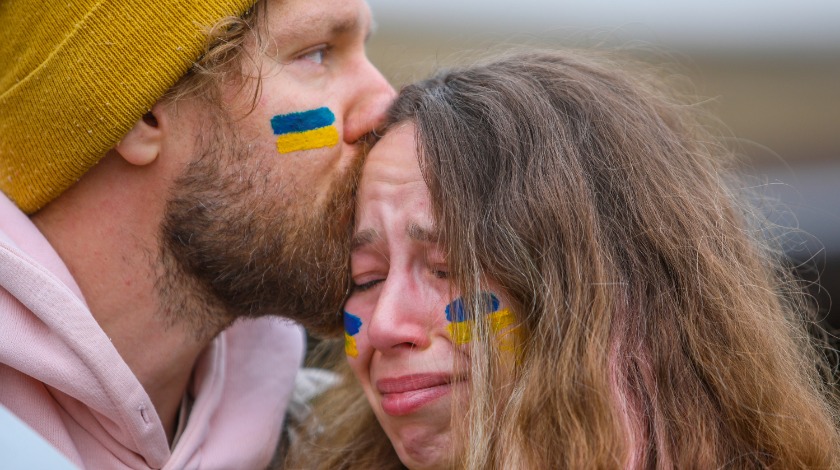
[376,374,459,416]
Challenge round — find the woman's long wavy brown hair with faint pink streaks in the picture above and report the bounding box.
[284,51,840,469]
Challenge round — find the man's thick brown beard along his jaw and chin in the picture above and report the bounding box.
[156,116,361,339]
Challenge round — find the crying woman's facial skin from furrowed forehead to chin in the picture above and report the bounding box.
[345,124,466,469]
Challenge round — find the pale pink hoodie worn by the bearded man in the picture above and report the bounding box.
[0,193,304,469]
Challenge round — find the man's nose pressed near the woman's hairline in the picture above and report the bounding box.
[344,58,396,144]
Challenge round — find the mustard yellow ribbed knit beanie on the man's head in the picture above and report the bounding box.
[0,0,255,213]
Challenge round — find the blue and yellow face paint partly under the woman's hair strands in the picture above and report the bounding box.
[446,292,519,351]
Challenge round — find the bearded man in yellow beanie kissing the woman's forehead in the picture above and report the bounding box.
[0,0,393,468]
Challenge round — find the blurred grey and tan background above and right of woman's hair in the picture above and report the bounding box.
[368,0,840,328]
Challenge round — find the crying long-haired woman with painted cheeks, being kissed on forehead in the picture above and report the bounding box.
[290,52,840,469]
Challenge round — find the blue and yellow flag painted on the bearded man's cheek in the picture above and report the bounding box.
[271,107,338,153]
